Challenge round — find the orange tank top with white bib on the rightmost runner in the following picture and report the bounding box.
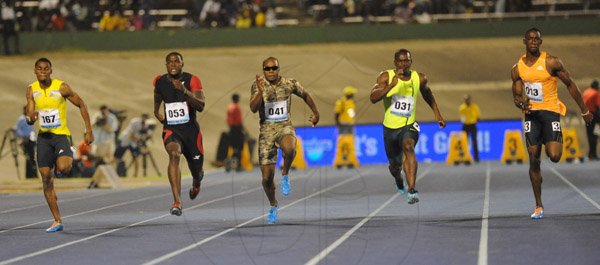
[517,52,566,115]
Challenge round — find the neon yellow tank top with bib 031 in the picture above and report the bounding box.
[383,70,421,129]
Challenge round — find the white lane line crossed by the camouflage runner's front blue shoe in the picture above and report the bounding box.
[143,170,361,265]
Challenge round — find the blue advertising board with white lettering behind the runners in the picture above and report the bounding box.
[277,120,522,166]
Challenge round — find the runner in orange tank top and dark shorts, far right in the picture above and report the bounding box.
[511,28,593,219]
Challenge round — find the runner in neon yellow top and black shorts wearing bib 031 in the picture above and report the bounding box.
[371,49,446,204]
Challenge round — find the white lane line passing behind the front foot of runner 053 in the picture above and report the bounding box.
[0,186,262,265]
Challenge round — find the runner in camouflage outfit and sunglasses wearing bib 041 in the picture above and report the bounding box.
[250,57,319,224]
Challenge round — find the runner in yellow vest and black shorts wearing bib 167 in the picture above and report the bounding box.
[26,58,94,233]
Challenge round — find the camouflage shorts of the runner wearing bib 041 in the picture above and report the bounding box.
[258,121,296,165]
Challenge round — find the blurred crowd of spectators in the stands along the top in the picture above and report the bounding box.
[0,0,598,31]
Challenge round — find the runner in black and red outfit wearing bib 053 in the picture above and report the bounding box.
[154,52,205,216]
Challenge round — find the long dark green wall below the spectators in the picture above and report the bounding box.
[21,18,600,53]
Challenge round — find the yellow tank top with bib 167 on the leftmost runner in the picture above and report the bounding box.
[31,79,71,135]
